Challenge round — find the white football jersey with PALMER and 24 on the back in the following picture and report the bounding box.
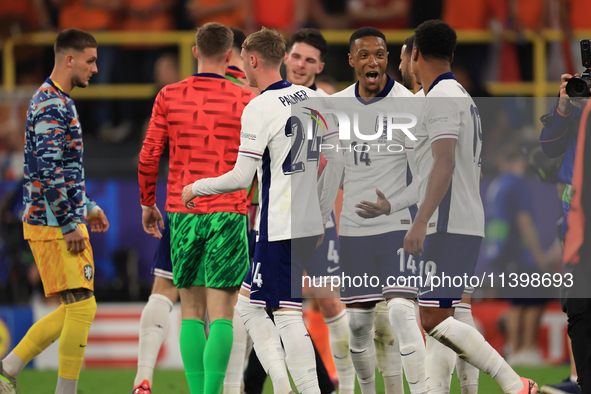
[238,81,336,241]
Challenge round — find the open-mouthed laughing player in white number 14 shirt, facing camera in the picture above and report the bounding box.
[332,27,426,394]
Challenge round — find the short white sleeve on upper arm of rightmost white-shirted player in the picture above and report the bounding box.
[424,97,461,143]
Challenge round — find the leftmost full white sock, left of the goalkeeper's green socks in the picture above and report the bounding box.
[133,294,173,386]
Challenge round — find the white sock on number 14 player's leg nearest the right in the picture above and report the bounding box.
[388,298,427,394]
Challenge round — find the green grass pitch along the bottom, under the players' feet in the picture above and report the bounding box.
[19,366,570,394]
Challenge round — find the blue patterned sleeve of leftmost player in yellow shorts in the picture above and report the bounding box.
[35,99,78,235]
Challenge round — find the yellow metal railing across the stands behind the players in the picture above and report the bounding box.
[0,30,591,123]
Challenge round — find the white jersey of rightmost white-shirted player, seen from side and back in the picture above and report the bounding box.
[414,73,484,237]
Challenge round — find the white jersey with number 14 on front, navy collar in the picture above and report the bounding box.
[331,78,422,237]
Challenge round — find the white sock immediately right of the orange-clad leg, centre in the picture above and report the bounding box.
[324,309,355,394]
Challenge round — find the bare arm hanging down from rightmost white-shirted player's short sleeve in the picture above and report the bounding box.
[404,138,457,256]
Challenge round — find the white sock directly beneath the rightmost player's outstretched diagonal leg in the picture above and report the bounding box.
[425,335,458,394]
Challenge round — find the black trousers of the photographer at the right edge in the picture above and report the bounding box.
[561,260,591,394]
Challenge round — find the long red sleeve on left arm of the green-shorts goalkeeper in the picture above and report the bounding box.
[138,87,168,206]
